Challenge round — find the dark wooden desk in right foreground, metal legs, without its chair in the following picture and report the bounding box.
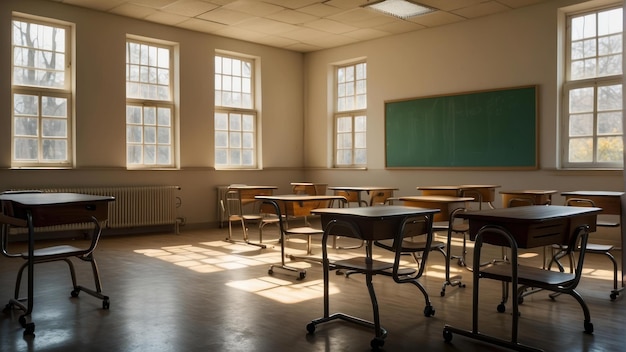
[443,205,602,351]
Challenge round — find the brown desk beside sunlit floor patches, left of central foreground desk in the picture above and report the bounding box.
[255,194,346,279]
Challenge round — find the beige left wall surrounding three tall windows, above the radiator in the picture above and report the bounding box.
[0,0,304,225]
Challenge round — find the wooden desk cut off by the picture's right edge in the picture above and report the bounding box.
[561,191,626,299]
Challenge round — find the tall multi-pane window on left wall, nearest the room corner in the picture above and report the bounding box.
[215,54,258,168]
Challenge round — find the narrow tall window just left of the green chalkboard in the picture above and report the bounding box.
[335,62,367,167]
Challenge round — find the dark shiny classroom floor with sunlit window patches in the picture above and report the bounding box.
[0,229,626,352]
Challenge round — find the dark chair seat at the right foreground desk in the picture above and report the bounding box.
[480,265,576,288]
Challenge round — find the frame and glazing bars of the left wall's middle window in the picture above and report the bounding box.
[124,35,178,170]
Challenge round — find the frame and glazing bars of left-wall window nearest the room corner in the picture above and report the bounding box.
[213,50,261,170]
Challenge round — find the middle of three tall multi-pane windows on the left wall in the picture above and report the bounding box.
[126,40,175,168]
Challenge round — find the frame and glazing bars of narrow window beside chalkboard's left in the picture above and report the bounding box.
[332,59,367,168]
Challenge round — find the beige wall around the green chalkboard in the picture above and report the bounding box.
[305,1,624,209]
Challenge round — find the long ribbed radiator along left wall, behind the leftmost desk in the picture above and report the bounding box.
[9,186,181,233]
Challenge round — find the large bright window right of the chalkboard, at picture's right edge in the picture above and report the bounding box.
[562,7,624,169]
